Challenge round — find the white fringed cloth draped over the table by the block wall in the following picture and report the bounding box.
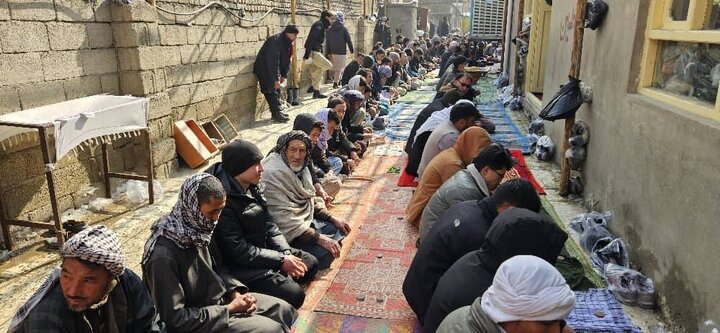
[0,95,149,161]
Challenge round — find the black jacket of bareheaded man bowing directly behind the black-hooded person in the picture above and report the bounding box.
[403,198,498,323]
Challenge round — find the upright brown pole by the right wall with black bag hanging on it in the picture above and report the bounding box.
[560,0,587,196]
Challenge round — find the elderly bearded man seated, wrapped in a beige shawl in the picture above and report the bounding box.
[262,131,350,269]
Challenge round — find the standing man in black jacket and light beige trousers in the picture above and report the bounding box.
[303,10,335,98]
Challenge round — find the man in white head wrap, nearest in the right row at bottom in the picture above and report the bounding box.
[436,255,575,333]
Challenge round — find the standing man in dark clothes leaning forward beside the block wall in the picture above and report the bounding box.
[253,24,299,123]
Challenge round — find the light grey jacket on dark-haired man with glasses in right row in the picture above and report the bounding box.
[420,164,490,239]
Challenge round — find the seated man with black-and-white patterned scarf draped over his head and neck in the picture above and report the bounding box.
[142,173,297,333]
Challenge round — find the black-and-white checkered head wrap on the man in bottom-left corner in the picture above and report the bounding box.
[60,225,125,276]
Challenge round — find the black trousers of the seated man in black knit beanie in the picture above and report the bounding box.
[243,249,319,309]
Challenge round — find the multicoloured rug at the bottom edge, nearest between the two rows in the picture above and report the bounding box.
[292,312,422,333]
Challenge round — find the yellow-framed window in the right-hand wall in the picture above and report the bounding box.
[638,0,720,121]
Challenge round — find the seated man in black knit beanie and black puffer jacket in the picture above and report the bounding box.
[206,140,318,308]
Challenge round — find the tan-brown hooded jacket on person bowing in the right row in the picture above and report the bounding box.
[405,127,492,226]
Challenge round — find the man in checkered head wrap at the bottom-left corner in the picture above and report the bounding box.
[8,226,160,333]
